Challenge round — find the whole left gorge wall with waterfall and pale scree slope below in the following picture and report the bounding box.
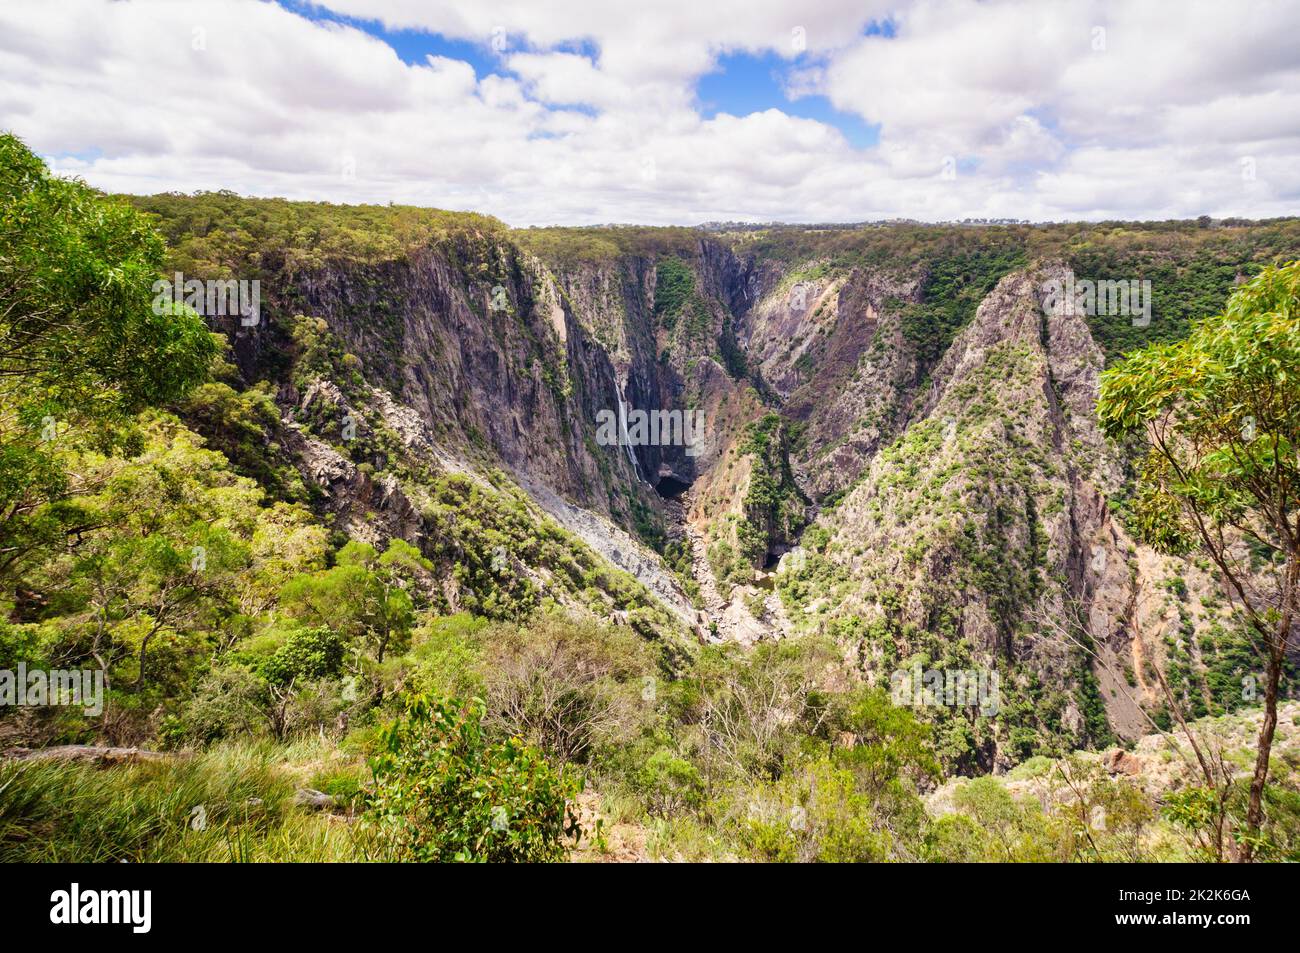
[223,239,780,629]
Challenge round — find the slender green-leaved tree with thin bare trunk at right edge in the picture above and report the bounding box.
[1097,263,1300,859]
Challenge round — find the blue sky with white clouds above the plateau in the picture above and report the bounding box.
[0,0,1300,226]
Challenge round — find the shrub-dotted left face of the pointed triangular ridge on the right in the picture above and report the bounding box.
[835,267,1076,663]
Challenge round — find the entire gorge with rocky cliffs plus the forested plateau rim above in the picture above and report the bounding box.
[129,196,1295,770]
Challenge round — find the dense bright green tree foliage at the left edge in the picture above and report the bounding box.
[0,134,216,581]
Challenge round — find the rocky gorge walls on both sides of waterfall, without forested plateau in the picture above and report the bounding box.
[185,210,1248,768]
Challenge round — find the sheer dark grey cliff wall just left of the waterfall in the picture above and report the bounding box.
[288,247,629,510]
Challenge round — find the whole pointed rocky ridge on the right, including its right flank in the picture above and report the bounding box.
[780,265,1248,767]
